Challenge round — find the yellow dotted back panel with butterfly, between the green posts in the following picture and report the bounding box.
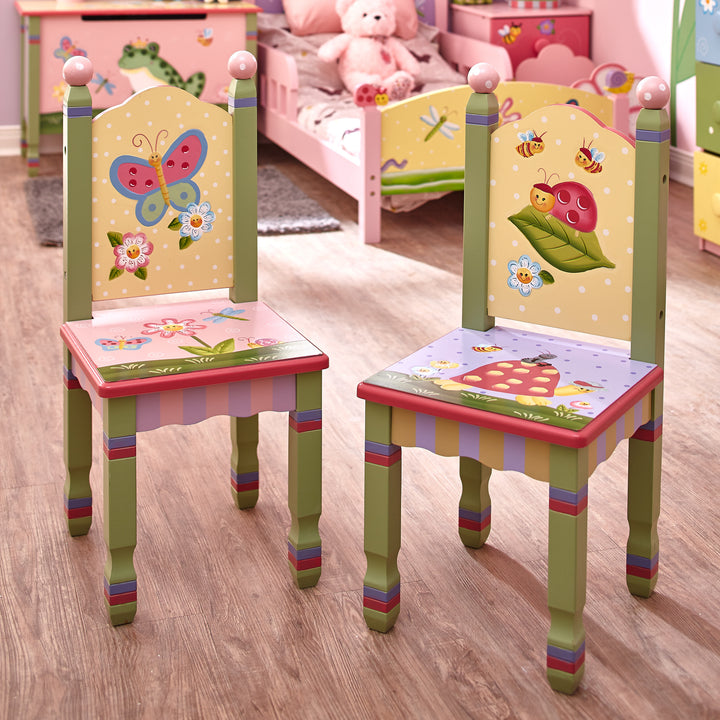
[92,87,233,301]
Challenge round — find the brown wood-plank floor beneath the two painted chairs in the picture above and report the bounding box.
[0,145,720,720]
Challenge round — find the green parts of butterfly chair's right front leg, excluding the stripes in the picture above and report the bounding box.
[288,372,322,588]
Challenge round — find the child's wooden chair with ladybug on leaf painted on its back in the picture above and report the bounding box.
[358,64,669,693]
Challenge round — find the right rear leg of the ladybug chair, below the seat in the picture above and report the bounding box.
[625,421,662,597]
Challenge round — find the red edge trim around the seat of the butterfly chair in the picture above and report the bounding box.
[60,325,330,398]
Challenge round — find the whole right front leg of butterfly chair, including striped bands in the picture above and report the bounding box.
[288,372,322,588]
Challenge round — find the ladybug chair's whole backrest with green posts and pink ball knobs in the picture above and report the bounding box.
[463,64,669,363]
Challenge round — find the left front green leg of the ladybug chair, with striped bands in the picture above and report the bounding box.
[363,402,402,632]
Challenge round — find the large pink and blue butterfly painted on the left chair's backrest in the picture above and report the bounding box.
[110,130,207,227]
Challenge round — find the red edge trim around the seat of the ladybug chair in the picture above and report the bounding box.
[357,367,663,448]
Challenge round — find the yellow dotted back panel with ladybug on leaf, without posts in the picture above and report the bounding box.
[488,105,635,340]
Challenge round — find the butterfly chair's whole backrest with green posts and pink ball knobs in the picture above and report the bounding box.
[63,51,257,320]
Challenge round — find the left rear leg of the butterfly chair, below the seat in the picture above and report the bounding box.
[63,358,92,536]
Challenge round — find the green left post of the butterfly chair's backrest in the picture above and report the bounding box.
[63,77,92,322]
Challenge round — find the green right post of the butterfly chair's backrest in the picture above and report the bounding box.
[229,69,258,302]
